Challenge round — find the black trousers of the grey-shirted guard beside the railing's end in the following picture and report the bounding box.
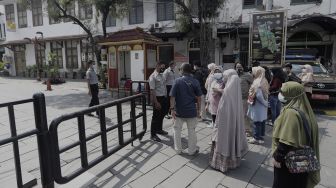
[151,97,167,136]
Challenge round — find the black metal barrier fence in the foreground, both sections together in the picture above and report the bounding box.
[0,93,147,188]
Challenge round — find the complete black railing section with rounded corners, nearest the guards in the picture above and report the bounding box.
[49,94,147,184]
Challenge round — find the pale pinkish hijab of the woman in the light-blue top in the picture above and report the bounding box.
[249,66,269,99]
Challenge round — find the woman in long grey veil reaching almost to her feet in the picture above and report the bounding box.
[210,69,248,172]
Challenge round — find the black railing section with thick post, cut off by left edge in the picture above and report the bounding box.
[0,93,52,188]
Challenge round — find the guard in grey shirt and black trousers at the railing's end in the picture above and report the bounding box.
[148,62,168,142]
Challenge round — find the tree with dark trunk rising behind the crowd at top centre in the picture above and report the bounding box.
[174,0,225,65]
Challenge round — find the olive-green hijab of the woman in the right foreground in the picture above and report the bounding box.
[272,82,320,187]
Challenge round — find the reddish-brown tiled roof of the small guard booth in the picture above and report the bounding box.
[99,27,161,45]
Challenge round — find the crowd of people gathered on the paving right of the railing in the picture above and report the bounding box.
[149,62,320,187]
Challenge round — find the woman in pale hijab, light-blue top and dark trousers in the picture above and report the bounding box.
[247,66,269,144]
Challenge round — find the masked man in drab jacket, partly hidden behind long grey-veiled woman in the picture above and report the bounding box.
[235,63,253,136]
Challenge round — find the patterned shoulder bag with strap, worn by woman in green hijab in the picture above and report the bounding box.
[285,108,321,173]
